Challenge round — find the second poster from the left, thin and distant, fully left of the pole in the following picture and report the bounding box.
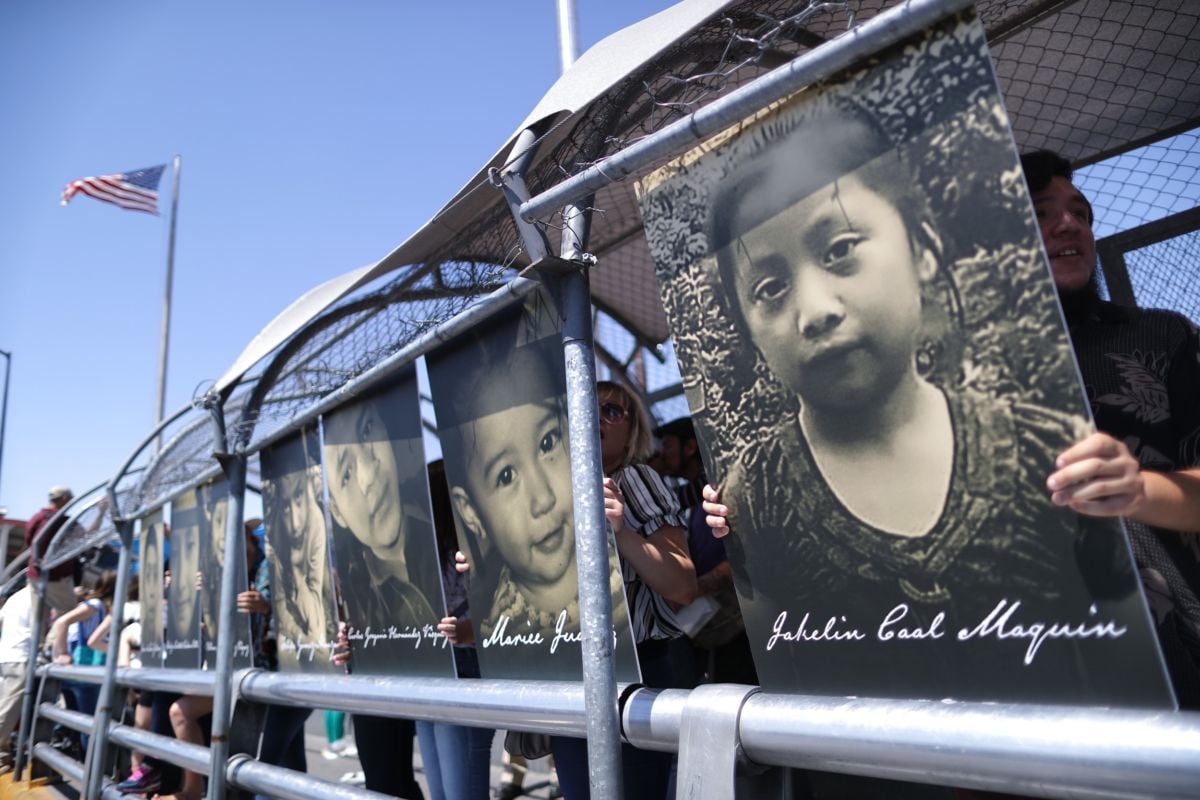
[163,489,204,669]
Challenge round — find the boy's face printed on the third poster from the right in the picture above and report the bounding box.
[325,403,404,561]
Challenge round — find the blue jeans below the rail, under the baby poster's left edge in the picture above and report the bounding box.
[416,722,496,800]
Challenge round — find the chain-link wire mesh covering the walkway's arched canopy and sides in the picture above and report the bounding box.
[114,0,1200,510]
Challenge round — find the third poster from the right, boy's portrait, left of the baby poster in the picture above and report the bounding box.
[322,368,455,678]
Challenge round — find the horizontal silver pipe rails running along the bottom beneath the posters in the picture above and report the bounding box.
[25,667,1200,798]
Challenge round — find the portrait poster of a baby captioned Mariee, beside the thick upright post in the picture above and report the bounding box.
[426,294,638,681]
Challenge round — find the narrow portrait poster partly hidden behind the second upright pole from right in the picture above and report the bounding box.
[198,480,251,669]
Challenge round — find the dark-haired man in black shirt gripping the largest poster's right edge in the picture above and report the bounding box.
[1021,151,1200,708]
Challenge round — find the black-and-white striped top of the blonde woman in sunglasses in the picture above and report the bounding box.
[612,464,688,642]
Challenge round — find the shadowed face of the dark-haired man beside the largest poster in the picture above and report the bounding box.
[1033,175,1096,291]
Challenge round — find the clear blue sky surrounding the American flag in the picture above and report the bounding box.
[0,0,671,518]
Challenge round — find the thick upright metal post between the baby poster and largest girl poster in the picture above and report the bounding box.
[560,201,622,800]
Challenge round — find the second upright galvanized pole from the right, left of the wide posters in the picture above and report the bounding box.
[208,453,246,800]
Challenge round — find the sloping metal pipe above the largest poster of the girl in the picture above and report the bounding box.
[521,0,972,221]
